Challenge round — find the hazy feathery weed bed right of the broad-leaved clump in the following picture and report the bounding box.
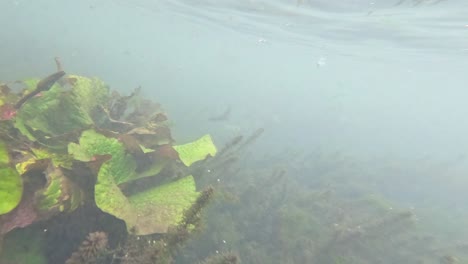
[177,147,468,264]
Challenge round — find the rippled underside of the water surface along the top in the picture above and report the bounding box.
[114,0,468,53]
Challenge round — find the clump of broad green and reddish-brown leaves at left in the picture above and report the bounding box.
[0,67,217,264]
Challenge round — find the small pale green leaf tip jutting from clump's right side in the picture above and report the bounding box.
[174,135,217,166]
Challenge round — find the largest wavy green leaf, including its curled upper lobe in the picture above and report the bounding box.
[68,130,203,234]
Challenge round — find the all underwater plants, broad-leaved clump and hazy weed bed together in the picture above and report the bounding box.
[0,60,468,264]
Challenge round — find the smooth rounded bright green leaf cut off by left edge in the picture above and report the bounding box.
[0,167,23,215]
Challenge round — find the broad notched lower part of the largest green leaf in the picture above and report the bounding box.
[95,167,198,235]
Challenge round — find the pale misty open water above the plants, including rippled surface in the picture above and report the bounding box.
[0,0,468,263]
